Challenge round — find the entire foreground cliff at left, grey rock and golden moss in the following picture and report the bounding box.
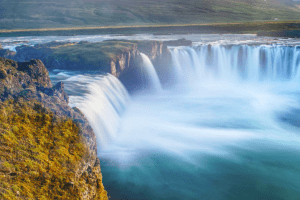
[0,58,108,199]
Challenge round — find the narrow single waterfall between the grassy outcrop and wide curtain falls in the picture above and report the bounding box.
[140,53,161,92]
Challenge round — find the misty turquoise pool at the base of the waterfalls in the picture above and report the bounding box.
[100,82,300,200]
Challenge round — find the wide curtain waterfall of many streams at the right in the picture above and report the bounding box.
[169,45,300,81]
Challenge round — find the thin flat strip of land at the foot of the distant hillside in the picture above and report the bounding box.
[0,20,300,37]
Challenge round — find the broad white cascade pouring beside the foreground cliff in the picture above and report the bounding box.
[66,74,129,148]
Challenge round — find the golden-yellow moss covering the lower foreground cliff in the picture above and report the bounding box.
[0,99,107,200]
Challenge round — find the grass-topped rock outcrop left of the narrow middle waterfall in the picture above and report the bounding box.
[0,41,139,77]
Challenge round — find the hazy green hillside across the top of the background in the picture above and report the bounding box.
[0,0,300,29]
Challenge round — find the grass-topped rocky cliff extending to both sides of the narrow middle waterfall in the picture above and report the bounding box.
[0,39,192,91]
